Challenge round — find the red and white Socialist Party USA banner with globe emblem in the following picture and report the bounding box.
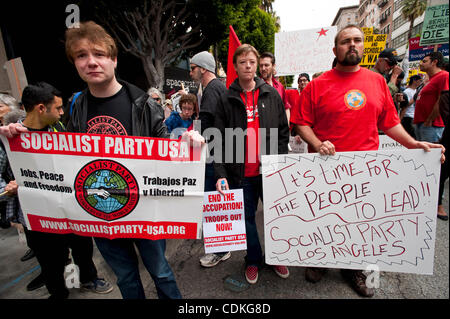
[2,132,205,239]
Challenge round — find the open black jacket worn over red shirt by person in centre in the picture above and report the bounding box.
[214,78,289,187]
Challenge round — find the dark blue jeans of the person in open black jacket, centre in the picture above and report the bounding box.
[241,175,263,268]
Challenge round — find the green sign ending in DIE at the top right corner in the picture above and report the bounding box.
[420,3,449,46]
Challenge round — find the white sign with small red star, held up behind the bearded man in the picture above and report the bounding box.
[275,26,337,76]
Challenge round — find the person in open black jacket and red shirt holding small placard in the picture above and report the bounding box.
[214,44,289,284]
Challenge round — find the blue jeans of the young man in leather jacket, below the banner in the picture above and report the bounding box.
[95,238,181,299]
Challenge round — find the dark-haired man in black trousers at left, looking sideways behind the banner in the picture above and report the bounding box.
[3,82,113,299]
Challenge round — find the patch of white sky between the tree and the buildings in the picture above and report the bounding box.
[272,0,359,31]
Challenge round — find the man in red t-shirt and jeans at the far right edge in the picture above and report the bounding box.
[414,52,448,143]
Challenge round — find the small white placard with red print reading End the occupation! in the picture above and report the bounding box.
[203,189,247,254]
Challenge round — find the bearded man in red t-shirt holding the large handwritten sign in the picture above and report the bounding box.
[291,25,443,297]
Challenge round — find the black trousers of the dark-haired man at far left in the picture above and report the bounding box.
[25,229,97,298]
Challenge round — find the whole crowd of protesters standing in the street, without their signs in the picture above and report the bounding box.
[0,22,449,299]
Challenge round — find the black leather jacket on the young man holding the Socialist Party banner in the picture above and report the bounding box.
[64,80,170,138]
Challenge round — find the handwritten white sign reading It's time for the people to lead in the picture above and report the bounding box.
[263,149,441,274]
